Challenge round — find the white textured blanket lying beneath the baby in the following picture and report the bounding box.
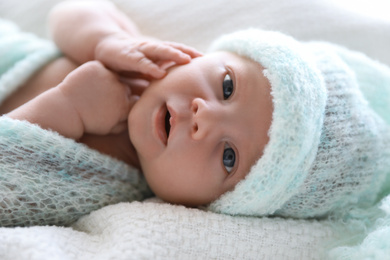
[0,202,344,260]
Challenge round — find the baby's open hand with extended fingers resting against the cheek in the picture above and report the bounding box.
[95,34,202,78]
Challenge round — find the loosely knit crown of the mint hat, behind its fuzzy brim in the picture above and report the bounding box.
[276,44,390,217]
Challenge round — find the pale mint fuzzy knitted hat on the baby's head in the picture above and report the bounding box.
[208,29,390,217]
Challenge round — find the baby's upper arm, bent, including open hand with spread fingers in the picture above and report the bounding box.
[49,1,200,78]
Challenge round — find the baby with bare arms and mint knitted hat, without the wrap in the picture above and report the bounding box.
[1,3,390,225]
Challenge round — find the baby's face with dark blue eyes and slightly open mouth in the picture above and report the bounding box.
[129,52,272,206]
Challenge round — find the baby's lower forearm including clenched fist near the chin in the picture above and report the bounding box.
[7,61,136,140]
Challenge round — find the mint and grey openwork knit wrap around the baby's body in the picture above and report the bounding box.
[0,20,151,226]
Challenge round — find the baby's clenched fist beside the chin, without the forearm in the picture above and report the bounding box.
[58,61,136,135]
